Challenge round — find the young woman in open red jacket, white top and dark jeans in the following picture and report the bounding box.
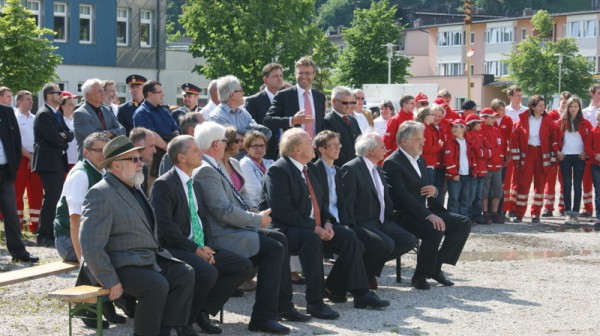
[556,97,592,224]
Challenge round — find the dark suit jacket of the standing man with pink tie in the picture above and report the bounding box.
[263,86,325,159]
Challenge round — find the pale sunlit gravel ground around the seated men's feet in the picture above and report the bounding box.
[0,217,600,336]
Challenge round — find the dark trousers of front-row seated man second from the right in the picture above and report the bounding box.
[352,219,417,278]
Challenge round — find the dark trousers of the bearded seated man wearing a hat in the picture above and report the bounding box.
[116,256,194,335]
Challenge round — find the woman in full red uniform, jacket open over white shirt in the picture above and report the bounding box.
[510,95,558,223]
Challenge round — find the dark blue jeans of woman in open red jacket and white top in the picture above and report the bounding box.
[559,154,585,214]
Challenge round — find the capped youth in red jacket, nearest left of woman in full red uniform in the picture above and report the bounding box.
[480,107,504,224]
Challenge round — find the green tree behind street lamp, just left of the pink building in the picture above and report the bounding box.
[338,0,412,86]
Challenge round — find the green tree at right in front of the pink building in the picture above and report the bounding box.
[504,11,593,99]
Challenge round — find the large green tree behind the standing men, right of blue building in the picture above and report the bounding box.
[181,0,334,92]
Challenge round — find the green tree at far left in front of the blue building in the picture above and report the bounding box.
[0,0,62,92]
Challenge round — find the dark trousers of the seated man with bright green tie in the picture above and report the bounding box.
[168,248,252,325]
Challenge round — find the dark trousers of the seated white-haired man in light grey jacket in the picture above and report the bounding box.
[249,229,293,320]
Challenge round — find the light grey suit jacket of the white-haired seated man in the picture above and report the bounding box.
[193,158,261,258]
